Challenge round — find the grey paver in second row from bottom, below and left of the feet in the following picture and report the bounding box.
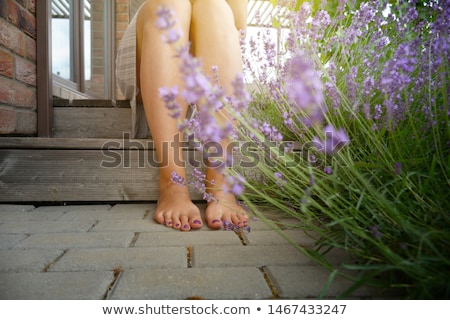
[49,247,187,271]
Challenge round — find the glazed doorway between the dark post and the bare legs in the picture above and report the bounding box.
[51,0,115,99]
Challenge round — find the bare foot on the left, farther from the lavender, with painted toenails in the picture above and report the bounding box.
[153,183,203,231]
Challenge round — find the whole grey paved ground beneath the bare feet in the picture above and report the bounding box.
[0,203,378,299]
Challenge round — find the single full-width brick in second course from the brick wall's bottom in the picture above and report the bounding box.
[0,77,36,109]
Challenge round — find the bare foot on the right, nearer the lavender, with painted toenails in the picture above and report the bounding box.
[205,191,248,229]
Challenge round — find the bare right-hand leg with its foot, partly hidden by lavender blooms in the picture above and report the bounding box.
[191,0,248,229]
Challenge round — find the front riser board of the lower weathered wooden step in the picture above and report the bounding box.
[0,149,201,203]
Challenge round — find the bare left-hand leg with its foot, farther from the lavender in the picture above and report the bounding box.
[136,0,202,231]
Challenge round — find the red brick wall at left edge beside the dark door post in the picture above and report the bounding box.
[0,0,37,135]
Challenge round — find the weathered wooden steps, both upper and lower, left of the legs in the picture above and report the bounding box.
[0,100,169,203]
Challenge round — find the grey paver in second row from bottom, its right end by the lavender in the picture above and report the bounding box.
[192,245,312,267]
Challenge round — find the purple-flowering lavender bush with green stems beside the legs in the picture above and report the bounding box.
[156,0,450,298]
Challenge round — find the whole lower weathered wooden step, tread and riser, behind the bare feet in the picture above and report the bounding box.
[0,137,260,203]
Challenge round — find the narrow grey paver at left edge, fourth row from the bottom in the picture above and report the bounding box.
[0,220,96,234]
